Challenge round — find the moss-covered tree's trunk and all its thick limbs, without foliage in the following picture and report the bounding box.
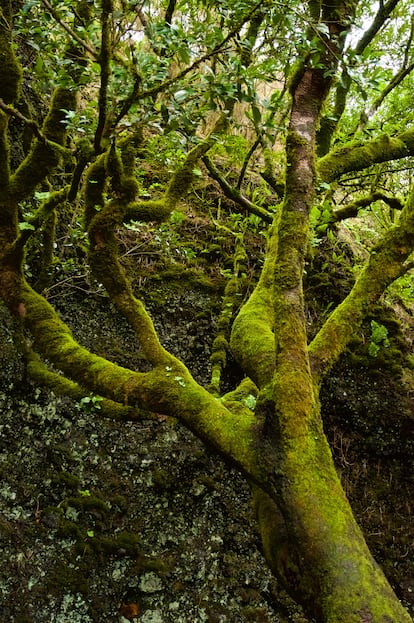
[0,2,414,623]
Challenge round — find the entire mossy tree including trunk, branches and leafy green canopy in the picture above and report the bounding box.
[0,0,414,623]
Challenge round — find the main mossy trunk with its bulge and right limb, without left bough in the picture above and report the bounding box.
[232,3,414,623]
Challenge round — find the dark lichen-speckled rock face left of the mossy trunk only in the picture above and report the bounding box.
[0,294,305,623]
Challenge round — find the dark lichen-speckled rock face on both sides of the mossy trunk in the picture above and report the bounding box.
[0,282,414,623]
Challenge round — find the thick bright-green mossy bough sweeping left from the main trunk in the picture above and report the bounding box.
[0,274,261,480]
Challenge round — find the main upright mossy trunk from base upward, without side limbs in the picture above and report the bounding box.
[244,54,411,623]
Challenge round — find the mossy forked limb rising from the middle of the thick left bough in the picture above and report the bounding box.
[85,117,225,365]
